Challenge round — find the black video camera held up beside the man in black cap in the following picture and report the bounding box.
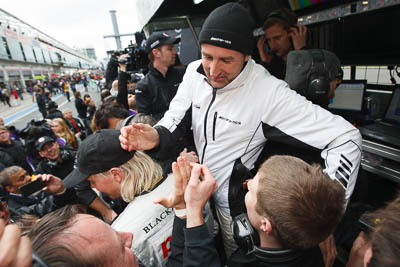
[114,41,149,73]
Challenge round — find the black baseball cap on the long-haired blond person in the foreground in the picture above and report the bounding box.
[63,129,136,188]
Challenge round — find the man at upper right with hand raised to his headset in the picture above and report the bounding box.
[257,8,308,80]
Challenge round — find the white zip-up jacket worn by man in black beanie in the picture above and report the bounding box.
[155,59,361,213]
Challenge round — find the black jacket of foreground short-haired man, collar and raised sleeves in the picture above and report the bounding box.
[167,216,325,267]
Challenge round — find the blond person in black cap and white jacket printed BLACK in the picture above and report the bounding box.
[63,129,175,267]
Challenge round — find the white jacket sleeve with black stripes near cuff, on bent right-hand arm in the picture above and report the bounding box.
[262,80,362,203]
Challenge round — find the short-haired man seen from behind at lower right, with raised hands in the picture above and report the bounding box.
[164,156,345,267]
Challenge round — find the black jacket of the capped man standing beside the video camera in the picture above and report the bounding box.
[135,63,186,121]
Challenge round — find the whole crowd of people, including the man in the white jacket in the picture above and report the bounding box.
[0,3,400,267]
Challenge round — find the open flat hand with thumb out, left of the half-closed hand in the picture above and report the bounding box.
[154,157,192,209]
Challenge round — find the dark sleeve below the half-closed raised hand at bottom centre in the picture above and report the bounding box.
[183,224,221,267]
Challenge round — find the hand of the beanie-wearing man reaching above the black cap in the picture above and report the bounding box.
[119,123,160,151]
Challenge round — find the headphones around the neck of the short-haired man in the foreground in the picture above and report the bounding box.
[232,213,260,255]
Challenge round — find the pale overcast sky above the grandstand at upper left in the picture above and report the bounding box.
[0,0,139,59]
